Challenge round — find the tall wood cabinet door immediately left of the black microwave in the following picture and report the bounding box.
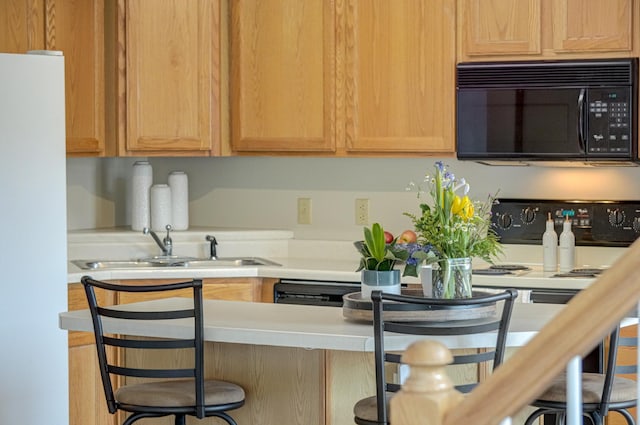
[344,0,455,153]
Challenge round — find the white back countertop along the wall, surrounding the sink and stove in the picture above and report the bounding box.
[68,228,624,289]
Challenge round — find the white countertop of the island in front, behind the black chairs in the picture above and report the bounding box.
[59,298,565,352]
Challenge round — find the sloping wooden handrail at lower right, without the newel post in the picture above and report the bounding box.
[440,239,640,425]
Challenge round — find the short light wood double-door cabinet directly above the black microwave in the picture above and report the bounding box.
[458,0,640,61]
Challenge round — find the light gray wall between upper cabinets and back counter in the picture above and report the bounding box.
[67,157,640,240]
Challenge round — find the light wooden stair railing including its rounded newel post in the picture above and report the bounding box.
[390,240,640,425]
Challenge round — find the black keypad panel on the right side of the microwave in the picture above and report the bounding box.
[586,88,633,156]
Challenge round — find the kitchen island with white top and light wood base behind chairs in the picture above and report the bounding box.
[60,298,563,425]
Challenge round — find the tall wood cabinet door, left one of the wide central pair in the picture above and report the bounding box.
[231,0,336,152]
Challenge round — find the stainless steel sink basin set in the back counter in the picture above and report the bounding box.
[71,256,280,270]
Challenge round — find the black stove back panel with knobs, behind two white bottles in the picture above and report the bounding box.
[491,199,640,247]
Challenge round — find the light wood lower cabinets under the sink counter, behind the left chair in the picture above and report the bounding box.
[68,278,272,425]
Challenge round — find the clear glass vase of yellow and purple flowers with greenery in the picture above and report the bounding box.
[405,161,502,298]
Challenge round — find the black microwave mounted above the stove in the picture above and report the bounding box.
[456,58,638,163]
